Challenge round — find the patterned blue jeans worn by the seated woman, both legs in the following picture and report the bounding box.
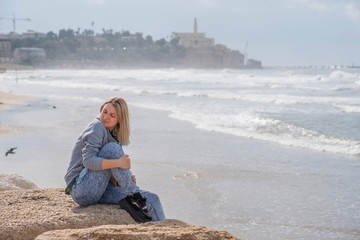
[71,143,165,221]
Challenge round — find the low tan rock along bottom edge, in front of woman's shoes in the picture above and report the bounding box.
[35,219,237,240]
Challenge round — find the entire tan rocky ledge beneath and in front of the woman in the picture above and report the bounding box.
[0,175,238,240]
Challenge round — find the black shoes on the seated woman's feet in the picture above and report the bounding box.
[119,192,152,223]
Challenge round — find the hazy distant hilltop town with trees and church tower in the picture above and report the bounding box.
[0,18,262,69]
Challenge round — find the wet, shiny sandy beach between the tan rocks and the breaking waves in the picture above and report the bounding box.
[0,68,360,240]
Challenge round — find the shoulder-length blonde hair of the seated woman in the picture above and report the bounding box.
[100,97,130,145]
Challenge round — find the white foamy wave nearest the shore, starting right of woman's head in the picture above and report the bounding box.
[134,103,360,156]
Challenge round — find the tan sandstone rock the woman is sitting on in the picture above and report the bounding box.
[0,188,135,240]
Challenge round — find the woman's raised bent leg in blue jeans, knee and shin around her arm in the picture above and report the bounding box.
[99,142,140,194]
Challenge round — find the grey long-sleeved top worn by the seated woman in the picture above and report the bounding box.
[64,117,117,185]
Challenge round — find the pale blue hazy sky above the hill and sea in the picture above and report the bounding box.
[0,0,360,66]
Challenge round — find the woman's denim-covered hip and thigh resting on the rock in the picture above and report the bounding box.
[71,168,111,205]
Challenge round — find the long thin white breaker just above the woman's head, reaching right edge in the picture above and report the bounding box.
[18,75,360,106]
